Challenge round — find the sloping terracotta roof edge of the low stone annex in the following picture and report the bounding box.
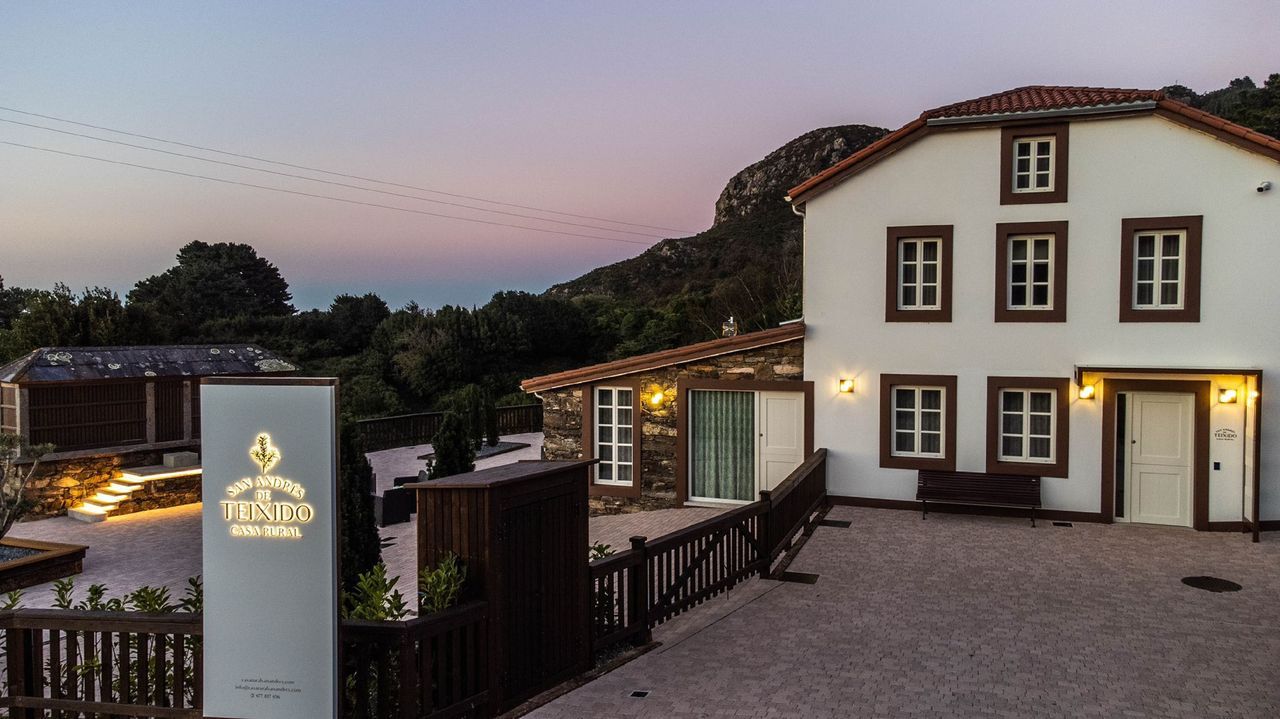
[520,322,804,391]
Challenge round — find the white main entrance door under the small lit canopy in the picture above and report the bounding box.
[1125,391,1197,527]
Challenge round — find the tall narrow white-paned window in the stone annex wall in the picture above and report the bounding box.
[582,380,644,496]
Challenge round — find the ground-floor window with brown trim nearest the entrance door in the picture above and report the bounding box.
[987,377,1071,477]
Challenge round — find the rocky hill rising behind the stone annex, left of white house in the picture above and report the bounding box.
[548,125,888,316]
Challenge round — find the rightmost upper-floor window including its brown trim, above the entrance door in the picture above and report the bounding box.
[1120,215,1204,322]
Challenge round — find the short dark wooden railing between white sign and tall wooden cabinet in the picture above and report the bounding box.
[342,601,489,719]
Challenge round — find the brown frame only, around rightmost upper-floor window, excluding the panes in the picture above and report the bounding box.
[1120,215,1204,322]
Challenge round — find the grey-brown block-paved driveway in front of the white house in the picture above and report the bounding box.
[531,508,1280,719]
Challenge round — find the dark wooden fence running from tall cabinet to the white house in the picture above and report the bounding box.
[591,449,827,650]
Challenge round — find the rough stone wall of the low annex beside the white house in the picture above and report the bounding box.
[539,339,804,514]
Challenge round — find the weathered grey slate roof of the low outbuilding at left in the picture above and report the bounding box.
[0,344,298,384]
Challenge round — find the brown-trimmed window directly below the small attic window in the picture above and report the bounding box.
[996,221,1066,322]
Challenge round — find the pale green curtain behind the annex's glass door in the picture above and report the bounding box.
[689,390,755,502]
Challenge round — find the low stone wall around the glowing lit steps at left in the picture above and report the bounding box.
[26,450,200,519]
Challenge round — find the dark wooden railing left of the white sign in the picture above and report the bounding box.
[0,609,204,719]
